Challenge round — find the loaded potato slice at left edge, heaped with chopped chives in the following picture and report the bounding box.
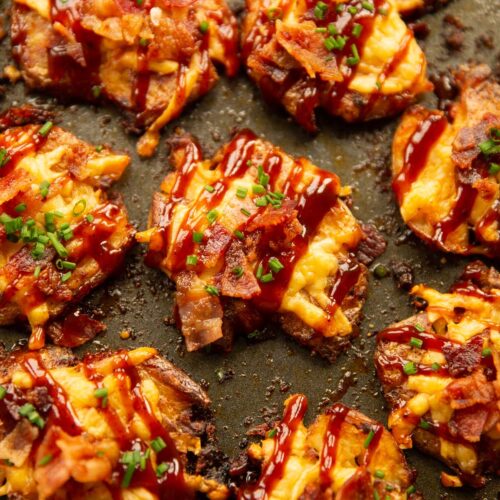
[0,108,134,348]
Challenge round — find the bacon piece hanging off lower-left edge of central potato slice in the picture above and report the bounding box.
[176,271,223,352]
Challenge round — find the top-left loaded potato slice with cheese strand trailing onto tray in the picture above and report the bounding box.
[11,0,238,156]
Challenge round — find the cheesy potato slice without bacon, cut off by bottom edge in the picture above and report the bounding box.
[238,394,420,500]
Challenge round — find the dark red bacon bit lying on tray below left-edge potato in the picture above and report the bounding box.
[47,309,106,347]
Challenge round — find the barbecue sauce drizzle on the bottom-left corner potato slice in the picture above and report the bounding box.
[7,351,193,500]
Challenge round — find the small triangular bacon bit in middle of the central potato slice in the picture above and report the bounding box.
[221,241,260,300]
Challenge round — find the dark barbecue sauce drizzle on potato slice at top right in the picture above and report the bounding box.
[242,0,413,131]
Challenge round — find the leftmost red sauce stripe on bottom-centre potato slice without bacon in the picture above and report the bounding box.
[238,394,307,500]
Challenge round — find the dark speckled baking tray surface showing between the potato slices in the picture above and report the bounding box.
[0,0,500,500]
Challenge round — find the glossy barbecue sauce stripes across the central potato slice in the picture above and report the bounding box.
[147,130,362,317]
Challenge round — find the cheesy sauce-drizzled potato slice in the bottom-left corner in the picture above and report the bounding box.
[0,347,227,500]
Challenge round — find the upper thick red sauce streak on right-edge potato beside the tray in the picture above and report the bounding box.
[392,113,448,204]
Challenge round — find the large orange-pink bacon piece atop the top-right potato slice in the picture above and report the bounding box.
[276,21,343,82]
